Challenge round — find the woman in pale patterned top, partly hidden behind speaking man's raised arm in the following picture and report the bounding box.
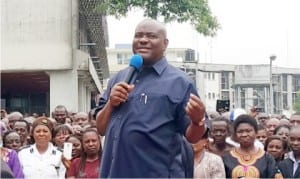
[193,129,225,178]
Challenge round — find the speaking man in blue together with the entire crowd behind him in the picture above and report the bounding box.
[0,19,300,179]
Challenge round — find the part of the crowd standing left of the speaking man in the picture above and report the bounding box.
[1,105,102,178]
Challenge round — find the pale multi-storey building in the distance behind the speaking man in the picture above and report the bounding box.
[107,44,300,115]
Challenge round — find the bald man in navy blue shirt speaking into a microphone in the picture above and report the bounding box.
[97,19,205,178]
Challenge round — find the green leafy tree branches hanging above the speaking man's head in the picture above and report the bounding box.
[96,0,220,36]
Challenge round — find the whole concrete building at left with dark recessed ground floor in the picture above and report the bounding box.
[1,0,109,116]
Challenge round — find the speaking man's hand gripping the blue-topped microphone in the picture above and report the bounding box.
[108,82,134,107]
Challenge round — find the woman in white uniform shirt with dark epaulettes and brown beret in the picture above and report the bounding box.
[18,117,66,179]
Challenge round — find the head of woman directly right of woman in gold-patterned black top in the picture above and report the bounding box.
[265,135,288,163]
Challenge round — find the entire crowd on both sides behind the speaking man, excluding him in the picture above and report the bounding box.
[1,105,300,178]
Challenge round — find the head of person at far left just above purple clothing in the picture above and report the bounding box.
[3,130,21,151]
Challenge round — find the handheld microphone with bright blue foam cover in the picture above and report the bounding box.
[125,54,143,84]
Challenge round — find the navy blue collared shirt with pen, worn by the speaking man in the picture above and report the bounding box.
[100,58,197,178]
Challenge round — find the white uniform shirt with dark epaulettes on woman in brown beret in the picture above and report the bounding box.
[18,143,66,179]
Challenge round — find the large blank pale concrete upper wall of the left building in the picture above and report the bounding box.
[1,0,76,71]
